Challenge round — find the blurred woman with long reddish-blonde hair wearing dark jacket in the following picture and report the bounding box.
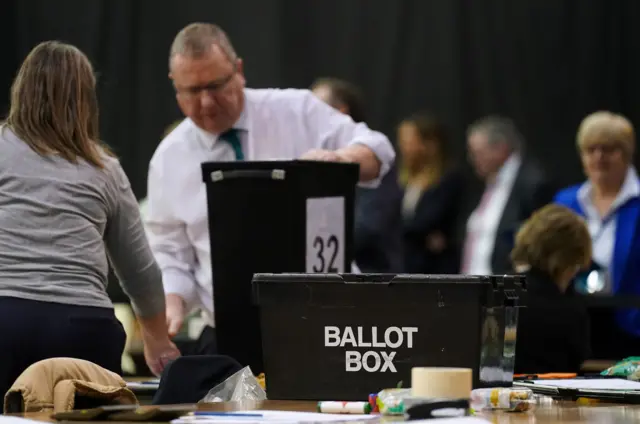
[398,113,463,274]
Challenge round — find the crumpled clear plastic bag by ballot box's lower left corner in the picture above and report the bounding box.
[201,367,267,402]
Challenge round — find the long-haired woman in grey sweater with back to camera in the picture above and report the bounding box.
[0,41,179,393]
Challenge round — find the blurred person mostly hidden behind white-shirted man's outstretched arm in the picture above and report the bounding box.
[311,78,403,273]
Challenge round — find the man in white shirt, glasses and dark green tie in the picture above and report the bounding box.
[146,23,395,353]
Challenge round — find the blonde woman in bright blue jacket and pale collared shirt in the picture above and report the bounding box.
[555,111,640,359]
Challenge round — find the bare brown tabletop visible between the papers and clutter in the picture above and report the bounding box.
[15,401,640,424]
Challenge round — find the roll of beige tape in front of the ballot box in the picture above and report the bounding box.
[411,368,473,399]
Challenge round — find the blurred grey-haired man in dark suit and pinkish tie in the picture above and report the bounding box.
[459,116,555,275]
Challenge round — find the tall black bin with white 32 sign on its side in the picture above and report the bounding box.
[200,161,359,373]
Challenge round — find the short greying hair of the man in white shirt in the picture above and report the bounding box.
[169,22,238,68]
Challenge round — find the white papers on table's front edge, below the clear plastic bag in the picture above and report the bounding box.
[171,411,380,424]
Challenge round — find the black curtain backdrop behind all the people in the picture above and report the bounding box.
[0,0,640,197]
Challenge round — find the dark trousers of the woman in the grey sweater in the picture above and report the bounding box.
[0,297,126,397]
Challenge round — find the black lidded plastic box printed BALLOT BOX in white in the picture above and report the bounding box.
[253,274,526,401]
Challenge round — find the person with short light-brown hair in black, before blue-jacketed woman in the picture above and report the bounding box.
[511,204,591,374]
